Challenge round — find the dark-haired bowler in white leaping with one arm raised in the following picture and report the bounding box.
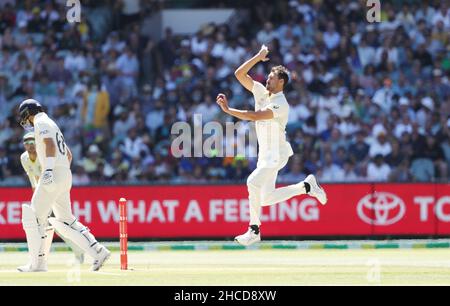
[217,45,327,246]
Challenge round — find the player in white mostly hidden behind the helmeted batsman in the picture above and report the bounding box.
[20,132,84,264]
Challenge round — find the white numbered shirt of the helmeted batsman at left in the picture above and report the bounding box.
[34,113,70,171]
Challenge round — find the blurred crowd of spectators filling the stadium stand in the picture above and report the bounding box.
[0,0,450,185]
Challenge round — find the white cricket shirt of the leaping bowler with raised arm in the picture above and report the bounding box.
[252,81,294,167]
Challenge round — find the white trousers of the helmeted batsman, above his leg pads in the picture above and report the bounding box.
[31,167,76,225]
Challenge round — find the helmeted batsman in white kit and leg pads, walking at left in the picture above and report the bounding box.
[18,99,111,272]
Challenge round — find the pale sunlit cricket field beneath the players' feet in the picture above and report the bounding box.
[0,249,450,286]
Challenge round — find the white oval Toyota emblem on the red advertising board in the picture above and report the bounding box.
[357,192,406,226]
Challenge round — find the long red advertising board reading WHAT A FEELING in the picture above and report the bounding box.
[0,184,450,240]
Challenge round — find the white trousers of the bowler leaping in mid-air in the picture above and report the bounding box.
[247,157,306,226]
